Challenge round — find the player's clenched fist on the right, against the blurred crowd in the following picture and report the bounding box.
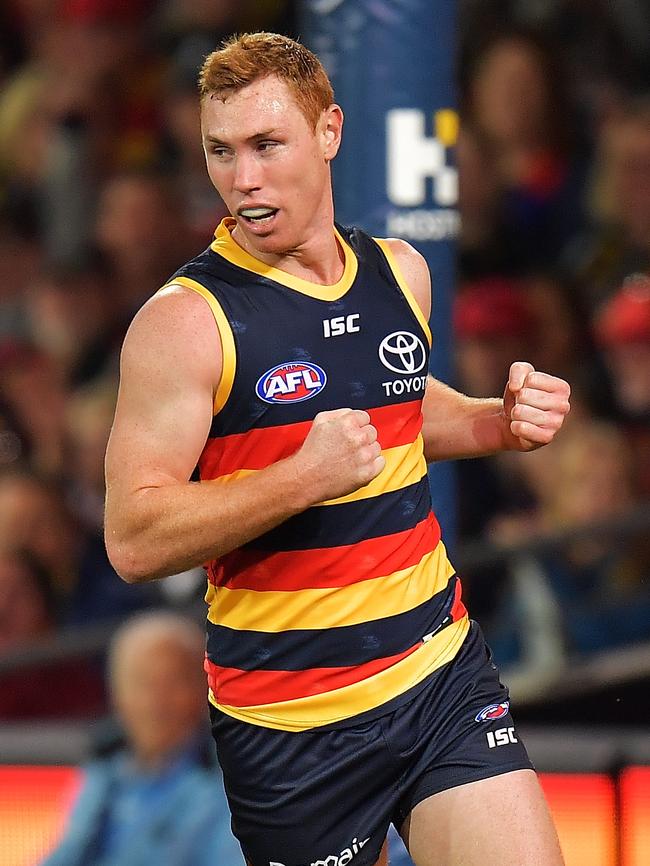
[503,361,571,451]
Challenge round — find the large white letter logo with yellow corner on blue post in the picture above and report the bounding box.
[386,108,458,207]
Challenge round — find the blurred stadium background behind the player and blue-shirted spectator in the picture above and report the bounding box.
[0,0,650,866]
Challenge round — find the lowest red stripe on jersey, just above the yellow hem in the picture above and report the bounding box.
[205,641,422,707]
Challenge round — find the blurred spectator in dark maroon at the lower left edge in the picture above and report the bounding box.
[0,549,105,721]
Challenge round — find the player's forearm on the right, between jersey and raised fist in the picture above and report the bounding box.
[422,379,507,463]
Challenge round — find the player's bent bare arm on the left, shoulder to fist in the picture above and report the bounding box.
[105,287,384,582]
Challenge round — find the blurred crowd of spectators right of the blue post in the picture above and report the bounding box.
[454,0,650,684]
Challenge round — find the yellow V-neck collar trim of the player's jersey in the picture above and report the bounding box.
[210,217,359,301]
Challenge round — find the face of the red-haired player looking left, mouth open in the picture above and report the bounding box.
[201,75,342,254]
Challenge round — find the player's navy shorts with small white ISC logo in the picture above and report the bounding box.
[211,623,532,866]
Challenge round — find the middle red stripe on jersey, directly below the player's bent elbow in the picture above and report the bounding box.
[208,512,440,591]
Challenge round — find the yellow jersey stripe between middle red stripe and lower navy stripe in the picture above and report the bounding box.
[206,541,454,633]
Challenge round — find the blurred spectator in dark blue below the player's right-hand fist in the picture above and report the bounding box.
[541,422,650,654]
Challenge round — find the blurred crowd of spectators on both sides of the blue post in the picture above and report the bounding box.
[0,0,650,718]
